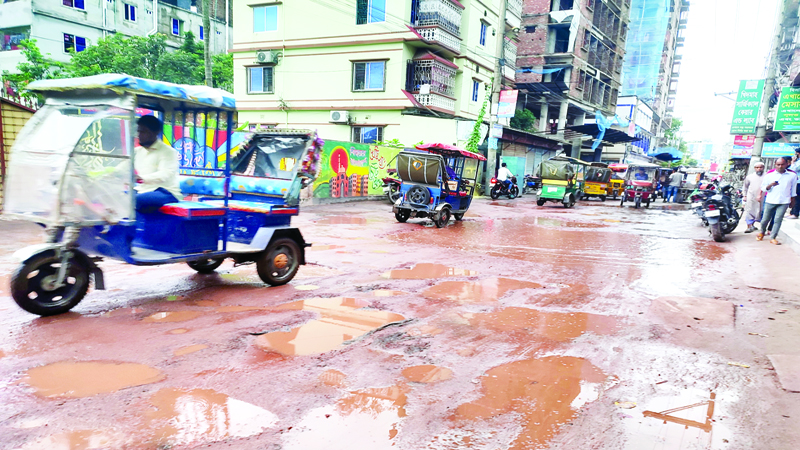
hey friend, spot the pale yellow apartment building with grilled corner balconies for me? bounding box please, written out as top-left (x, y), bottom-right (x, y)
top-left (232, 0), bottom-right (521, 145)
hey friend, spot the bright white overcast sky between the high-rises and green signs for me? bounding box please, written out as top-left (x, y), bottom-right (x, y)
top-left (674, 0), bottom-right (778, 143)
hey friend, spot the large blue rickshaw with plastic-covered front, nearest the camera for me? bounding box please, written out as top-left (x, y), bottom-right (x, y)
top-left (4, 74), bottom-right (322, 316)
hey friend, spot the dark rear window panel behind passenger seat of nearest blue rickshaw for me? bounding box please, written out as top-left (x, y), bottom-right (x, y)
top-left (231, 134), bottom-right (311, 180)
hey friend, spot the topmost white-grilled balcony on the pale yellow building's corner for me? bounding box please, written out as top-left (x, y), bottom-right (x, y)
top-left (411, 0), bottom-right (464, 53)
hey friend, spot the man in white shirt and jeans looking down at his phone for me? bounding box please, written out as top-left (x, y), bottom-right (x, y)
top-left (756, 156), bottom-right (797, 245)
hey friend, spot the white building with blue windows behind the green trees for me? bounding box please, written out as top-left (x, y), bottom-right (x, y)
top-left (0, 0), bottom-right (230, 72)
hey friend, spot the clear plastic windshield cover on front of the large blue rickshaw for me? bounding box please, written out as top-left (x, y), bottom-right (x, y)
top-left (4, 104), bottom-right (132, 224)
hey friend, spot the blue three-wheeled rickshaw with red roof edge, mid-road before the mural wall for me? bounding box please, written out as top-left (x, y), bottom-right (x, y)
top-left (392, 144), bottom-right (486, 228)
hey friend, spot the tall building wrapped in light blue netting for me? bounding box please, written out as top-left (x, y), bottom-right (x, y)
top-left (621, 0), bottom-right (690, 144)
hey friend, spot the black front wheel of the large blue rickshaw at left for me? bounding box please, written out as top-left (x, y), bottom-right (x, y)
top-left (11, 254), bottom-right (89, 316)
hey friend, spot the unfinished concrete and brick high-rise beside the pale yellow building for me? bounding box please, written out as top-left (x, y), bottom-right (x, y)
top-left (516, 0), bottom-right (630, 159)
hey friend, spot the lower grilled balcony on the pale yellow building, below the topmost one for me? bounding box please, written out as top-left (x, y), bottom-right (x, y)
top-left (406, 52), bottom-right (458, 113)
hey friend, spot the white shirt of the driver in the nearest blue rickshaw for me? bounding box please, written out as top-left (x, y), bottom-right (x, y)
top-left (133, 140), bottom-right (181, 198)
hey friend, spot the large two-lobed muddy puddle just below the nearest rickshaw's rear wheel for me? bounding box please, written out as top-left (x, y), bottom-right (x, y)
top-left (255, 297), bottom-right (405, 355)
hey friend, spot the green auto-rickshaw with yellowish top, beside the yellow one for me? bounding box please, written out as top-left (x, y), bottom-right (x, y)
top-left (536, 156), bottom-right (589, 208)
